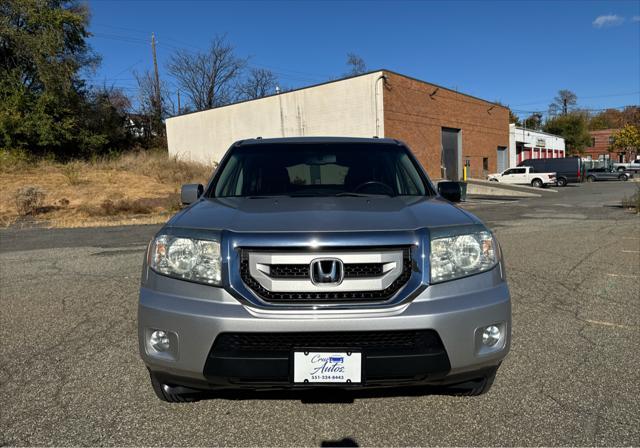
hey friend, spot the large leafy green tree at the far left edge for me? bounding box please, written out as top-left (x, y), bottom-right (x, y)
top-left (0, 0), bottom-right (122, 157)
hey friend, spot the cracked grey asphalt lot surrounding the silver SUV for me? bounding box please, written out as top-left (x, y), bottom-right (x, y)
top-left (0, 182), bottom-right (640, 446)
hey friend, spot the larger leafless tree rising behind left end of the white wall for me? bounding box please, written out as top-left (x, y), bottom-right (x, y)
top-left (167, 36), bottom-right (247, 110)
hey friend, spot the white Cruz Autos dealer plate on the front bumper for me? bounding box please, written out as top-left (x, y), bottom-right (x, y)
top-left (293, 352), bottom-right (362, 383)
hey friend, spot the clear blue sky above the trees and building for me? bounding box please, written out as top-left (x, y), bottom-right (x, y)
top-left (89, 1), bottom-right (640, 115)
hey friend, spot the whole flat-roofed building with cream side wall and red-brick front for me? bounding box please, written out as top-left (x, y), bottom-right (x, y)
top-left (167, 70), bottom-right (509, 179)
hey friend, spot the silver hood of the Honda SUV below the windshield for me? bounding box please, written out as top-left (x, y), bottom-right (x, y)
top-left (168, 197), bottom-right (479, 232)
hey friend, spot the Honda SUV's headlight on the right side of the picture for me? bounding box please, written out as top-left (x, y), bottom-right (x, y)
top-left (430, 231), bottom-right (498, 283)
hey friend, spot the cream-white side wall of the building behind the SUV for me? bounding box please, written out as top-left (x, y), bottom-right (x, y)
top-left (167, 72), bottom-right (384, 163)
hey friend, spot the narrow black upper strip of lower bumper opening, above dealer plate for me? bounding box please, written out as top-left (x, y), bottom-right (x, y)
top-left (210, 330), bottom-right (444, 356)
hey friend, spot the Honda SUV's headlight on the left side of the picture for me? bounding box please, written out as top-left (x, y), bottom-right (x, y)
top-left (148, 235), bottom-right (222, 285)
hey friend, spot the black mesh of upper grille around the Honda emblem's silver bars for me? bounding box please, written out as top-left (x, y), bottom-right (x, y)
top-left (240, 248), bottom-right (412, 304)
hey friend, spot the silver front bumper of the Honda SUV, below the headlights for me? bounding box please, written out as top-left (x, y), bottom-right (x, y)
top-left (138, 266), bottom-right (511, 388)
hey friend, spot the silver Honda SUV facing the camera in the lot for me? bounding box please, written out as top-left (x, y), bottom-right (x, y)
top-left (138, 138), bottom-right (511, 402)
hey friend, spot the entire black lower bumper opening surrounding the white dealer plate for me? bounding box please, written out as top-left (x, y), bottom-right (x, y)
top-left (203, 329), bottom-right (451, 387)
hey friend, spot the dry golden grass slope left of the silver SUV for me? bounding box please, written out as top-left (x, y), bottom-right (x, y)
top-left (0, 151), bottom-right (214, 227)
